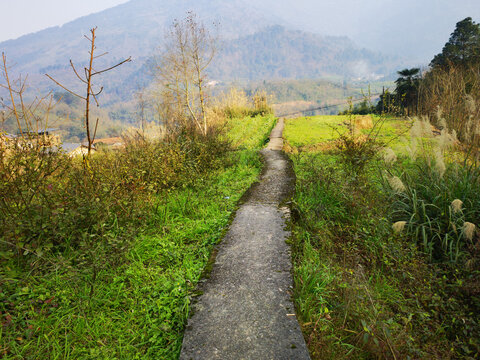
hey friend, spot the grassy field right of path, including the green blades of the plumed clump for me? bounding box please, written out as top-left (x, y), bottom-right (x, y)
top-left (284, 117), bottom-right (480, 359)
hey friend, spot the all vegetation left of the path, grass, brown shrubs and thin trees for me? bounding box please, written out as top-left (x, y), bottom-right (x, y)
top-left (0, 16), bottom-right (276, 360)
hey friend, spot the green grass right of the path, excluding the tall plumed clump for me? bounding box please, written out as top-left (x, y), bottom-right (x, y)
top-left (285, 117), bottom-right (480, 359)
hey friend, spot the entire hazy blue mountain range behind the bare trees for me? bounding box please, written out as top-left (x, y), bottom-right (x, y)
top-left (0, 0), bottom-right (404, 104)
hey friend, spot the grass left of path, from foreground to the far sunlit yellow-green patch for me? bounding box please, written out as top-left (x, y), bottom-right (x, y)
top-left (0, 117), bottom-right (275, 359)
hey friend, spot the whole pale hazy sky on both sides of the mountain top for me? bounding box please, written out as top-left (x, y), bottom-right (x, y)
top-left (0, 0), bottom-right (480, 62)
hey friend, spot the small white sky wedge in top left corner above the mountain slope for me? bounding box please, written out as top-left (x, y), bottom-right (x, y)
top-left (0, 0), bottom-right (128, 42)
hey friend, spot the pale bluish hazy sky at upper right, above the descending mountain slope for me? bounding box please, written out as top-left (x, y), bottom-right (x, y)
top-left (252, 0), bottom-right (480, 61)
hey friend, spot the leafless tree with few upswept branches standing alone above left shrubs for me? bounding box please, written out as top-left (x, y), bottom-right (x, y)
top-left (45, 27), bottom-right (131, 156)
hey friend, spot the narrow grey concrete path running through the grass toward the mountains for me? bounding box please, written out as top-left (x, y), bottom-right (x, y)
top-left (180, 120), bottom-right (310, 360)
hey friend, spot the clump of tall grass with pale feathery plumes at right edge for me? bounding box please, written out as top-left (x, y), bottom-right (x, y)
top-left (384, 117), bottom-right (480, 265)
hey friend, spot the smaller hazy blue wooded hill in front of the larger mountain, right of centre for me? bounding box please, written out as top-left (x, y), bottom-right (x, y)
top-left (211, 25), bottom-right (401, 80)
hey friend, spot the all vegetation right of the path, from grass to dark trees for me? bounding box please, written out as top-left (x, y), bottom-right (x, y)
top-left (284, 18), bottom-right (480, 359)
